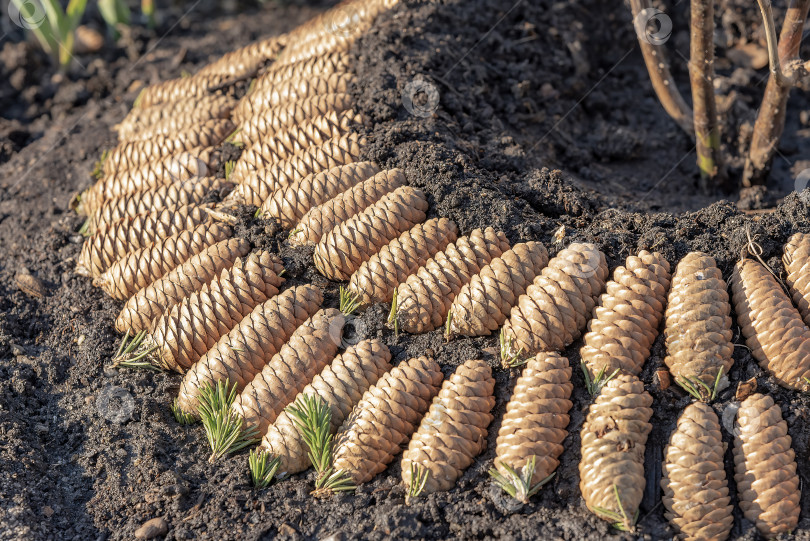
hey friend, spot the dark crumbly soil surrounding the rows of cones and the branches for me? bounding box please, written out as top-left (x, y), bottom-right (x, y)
top-left (0, 0), bottom-right (810, 539)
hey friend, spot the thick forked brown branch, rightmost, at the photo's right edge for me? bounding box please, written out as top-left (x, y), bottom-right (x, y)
top-left (742, 0), bottom-right (810, 186)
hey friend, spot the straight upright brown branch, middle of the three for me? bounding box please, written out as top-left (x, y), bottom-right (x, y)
top-left (689, 0), bottom-right (725, 193)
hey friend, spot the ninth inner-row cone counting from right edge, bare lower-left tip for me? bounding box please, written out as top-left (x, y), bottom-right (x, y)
top-left (312, 186), bottom-right (428, 280)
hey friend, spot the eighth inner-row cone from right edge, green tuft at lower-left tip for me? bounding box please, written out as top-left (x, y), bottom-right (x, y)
top-left (349, 218), bottom-right (458, 306)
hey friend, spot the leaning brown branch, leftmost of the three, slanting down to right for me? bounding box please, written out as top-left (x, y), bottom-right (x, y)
top-left (630, 0), bottom-right (695, 137)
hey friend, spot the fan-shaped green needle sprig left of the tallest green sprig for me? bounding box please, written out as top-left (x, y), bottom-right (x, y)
top-left (199, 380), bottom-right (260, 462)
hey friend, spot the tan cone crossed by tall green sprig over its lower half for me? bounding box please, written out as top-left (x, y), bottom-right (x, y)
top-left (261, 339), bottom-right (391, 474)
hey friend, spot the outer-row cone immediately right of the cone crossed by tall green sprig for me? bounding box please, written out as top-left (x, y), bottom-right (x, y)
top-left (333, 357), bottom-right (442, 484)
